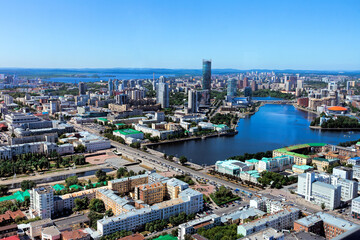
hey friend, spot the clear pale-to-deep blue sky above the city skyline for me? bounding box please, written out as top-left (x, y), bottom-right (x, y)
top-left (0, 0), bottom-right (360, 70)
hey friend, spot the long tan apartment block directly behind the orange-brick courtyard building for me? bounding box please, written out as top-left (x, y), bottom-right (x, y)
top-left (108, 174), bottom-right (149, 194)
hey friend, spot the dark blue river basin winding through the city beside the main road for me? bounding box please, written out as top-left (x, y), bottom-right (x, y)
top-left (150, 104), bottom-right (360, 165)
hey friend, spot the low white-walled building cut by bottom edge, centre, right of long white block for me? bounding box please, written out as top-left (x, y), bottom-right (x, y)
top-left (178, 214), bottom-right (221, 240)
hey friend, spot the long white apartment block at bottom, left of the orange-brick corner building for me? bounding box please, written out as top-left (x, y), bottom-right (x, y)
top-left (237, 208), bottom-right (300, 236)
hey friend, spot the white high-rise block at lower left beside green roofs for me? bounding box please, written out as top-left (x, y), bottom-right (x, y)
top-left (29, 186), bottom-right (54, 219)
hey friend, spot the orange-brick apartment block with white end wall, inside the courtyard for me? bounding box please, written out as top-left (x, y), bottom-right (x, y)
top-left (134, 182), bottom-right (166, 205)
